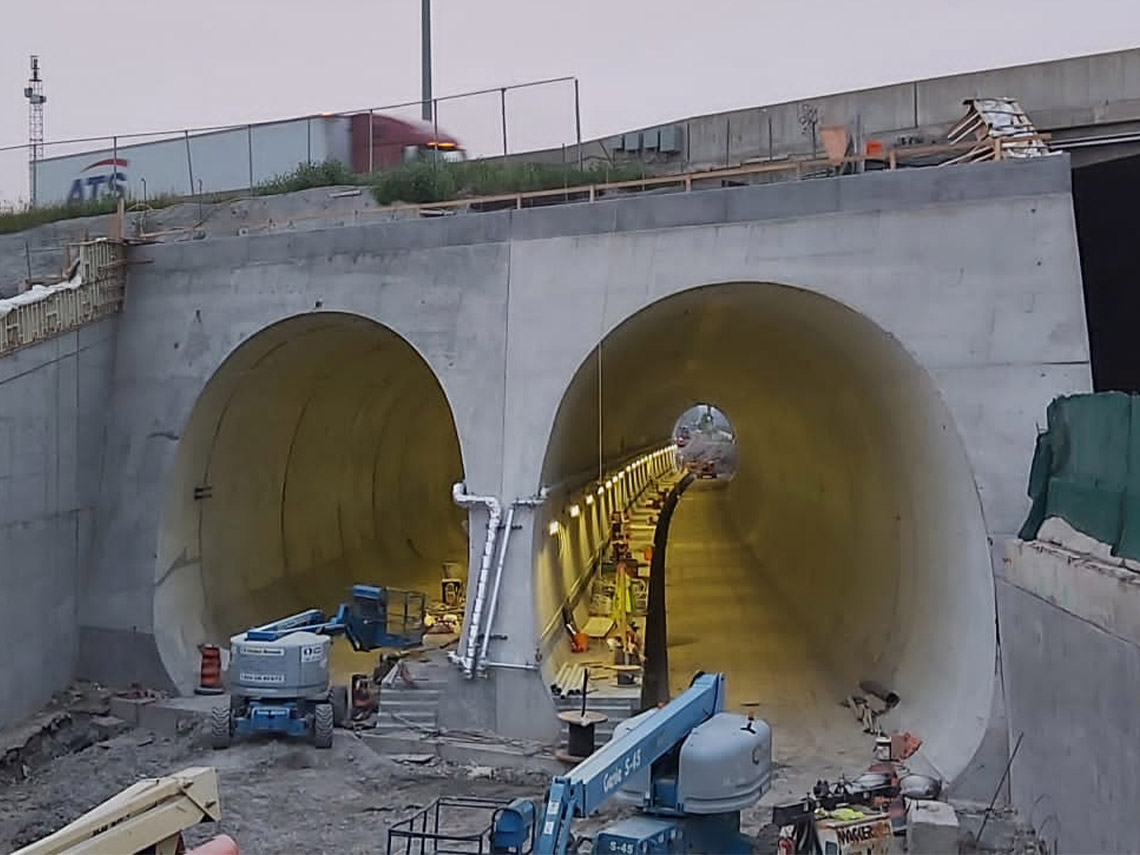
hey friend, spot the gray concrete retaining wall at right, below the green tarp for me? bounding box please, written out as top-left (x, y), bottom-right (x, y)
top-left (998, 542), bottom-right (1140, 853)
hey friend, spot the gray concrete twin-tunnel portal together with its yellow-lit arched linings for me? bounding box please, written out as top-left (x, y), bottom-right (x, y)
top-left (0, 158), bottom-right (1089, 776)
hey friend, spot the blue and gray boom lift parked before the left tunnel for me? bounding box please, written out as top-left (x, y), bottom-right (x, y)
top-left (210, 585), bottom-right (426, 749)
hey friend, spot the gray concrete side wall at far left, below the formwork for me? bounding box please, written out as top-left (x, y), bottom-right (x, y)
top-left (0, 319), bottom-right (117, 726)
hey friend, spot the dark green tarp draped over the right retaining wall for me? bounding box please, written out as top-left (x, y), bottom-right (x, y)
top-left (1019, 392), bottom-right (1140, 559)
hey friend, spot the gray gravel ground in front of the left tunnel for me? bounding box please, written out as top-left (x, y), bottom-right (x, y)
top-left (0, 731), bottom-right (546, 853)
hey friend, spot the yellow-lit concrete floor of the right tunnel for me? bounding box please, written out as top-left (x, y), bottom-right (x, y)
top-left (665, 480), bottom-right (873, 785)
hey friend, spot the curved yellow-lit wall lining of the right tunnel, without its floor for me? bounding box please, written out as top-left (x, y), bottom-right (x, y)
top-left (536, 283), bottom-right (995, 777)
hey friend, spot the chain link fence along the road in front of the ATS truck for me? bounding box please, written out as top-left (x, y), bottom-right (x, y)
top-left (0, 78), bottom-right (581, 211)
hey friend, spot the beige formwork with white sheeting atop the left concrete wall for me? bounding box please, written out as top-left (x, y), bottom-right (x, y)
top-left (0, 238), bottom-right (127, 357)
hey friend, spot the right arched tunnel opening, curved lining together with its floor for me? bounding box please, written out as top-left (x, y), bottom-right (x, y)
top-left (535, 283), bottom-right (996, 780)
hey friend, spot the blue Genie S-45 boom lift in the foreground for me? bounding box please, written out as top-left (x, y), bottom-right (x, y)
top-left (388, 674), bottom-right (772, 855)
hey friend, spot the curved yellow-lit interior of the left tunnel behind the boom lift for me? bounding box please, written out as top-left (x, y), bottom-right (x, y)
top-left (154, 312), bottom-right (467, 691)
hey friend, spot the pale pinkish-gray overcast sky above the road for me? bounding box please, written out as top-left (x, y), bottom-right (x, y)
top-left (0, 0), bottom-right (1140, 201)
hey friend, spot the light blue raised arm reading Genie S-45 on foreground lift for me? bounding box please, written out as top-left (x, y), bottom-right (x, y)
top-left (535, 674), bottom-right (725, 855)
